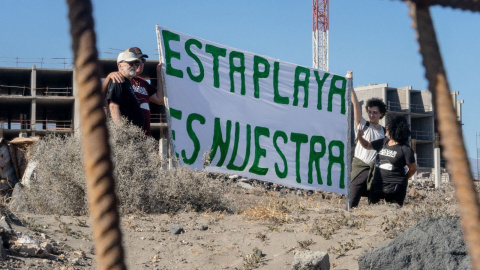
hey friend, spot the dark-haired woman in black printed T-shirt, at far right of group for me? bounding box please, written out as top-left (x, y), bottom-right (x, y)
top-left (357, 115), bottom-right (417, 206)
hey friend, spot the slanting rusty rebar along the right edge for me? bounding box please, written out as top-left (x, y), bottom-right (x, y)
top-left (409, 2), bottom-right (480, 269)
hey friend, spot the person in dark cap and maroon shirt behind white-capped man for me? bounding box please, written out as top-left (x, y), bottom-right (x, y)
top-left (102, 47), bottom-right (164, 135)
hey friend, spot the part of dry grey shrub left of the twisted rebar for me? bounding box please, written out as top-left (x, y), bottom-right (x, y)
top-left (25, 135), bottom-right (87, 215)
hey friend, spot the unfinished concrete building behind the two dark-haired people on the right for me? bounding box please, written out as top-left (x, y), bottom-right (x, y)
top-left (355, 83), bottom-right (463, 181)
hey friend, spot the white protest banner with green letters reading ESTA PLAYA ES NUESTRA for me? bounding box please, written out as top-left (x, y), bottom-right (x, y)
top-left (157, 25), bottom-right (349, 194)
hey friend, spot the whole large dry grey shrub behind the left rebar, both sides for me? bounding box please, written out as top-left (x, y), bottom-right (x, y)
top-left (25, 118), bottom-right (230, 215)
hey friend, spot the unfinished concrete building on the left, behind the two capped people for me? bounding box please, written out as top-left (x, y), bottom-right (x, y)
top-left (0, 59), bottom-right (167, 140)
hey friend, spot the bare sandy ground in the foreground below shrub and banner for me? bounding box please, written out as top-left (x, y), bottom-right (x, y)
top-left (4, 181), bottom-right (446, 270)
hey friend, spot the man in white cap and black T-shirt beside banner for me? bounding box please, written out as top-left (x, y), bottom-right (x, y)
top-left (106, 52), bottom-right (145, 128)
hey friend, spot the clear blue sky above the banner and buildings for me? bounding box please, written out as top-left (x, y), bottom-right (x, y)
top-left (0, 0), bottom-right (480, 158)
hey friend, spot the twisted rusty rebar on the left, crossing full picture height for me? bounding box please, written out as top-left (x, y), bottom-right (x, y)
top-left (67, 0), bottom-right (126, 269)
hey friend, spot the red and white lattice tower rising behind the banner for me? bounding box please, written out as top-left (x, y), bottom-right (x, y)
top-left (312, 0), bottom-right (329, 71)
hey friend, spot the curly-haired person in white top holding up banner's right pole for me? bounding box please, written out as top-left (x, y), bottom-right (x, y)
top-left (347, 71), bottom-right (387, 207)
